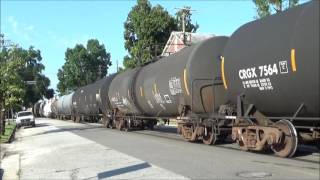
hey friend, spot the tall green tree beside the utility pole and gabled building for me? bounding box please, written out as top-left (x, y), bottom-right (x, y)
top-left (123, 0), bottom-right (198, 69)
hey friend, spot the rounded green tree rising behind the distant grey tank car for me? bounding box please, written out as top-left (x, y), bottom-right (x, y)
top-left (57, 39), bottom-right (111, 95)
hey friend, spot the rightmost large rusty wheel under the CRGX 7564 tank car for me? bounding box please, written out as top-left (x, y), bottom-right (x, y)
top-left (271, 119), bottom-right (298, 157)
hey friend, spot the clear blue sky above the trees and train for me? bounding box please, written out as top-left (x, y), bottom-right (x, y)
top-left (1, 0), bottom-right (308, 89)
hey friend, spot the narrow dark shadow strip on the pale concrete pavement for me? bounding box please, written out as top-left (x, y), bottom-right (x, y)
top-left (98, 162), bottom-right (151, 179)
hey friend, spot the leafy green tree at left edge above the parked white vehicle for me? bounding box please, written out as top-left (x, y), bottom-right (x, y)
top-left (0, 46), bottom-right (53, 108)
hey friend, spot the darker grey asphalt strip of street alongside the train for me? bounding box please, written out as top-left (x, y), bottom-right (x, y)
top-left (47, 118), bottom-right (320, 179)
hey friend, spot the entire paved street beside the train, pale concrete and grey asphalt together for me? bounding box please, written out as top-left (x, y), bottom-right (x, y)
top-left (1, 119), bottom-right (320, 179)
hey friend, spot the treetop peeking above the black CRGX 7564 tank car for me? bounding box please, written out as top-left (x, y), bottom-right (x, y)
top-left (253, 0), bottom-right (299, 19)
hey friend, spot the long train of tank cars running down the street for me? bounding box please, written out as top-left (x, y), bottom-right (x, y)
top-left (34, 1), bottom-right (320, 157)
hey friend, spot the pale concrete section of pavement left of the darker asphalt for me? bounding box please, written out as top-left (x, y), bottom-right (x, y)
top-left (2, 119), bottom-right (186, 180)
